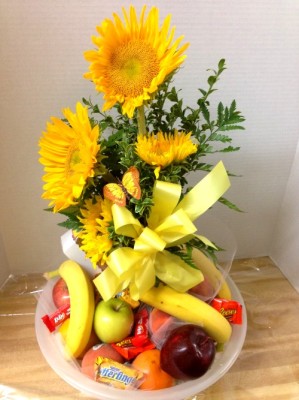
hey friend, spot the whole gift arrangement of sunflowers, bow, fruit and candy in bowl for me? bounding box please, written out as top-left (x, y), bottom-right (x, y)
top-left (36, 6), bottom-right (247, 400)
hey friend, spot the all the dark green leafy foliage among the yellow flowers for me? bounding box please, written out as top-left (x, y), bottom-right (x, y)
top-left (59, 59), bottom-right (245, 247)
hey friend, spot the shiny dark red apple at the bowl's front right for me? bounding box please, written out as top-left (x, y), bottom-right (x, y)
top-left (161, 324), bottom-right (216, 380)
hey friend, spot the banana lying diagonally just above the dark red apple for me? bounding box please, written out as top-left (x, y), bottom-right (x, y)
top-left (140, 285), bottom-right (232, 344)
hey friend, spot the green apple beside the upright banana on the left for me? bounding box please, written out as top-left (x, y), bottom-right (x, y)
top-left (93, 298), bottom-right (134, 343)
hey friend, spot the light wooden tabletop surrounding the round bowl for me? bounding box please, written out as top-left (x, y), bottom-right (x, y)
top-left (0, 257), bottom-right (299, 400)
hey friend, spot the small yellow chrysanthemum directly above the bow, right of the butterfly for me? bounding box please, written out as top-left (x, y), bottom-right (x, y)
top-left (136, 131), bottom-right (197, 177)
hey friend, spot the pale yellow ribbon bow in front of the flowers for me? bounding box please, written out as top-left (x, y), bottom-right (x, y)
top-left (94, 161), bottom-right (230, 300)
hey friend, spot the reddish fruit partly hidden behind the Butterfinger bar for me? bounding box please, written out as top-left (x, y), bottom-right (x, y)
top-left (81, 343), bottom-right (125, 379)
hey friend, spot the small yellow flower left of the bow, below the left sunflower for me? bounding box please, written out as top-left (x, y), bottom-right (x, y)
top-left (74, 196), bottom-right (113, 267)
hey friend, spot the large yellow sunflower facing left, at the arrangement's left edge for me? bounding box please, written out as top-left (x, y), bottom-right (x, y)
top-left (39, 103), bottom-right (100, 212)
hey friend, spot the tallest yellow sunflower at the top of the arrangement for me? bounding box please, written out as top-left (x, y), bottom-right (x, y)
top-left (84, 6), bottom-right (188, 118)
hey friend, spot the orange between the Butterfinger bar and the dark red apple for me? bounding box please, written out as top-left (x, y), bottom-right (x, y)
top-left (132, 349), bottom-right (175, 390)
